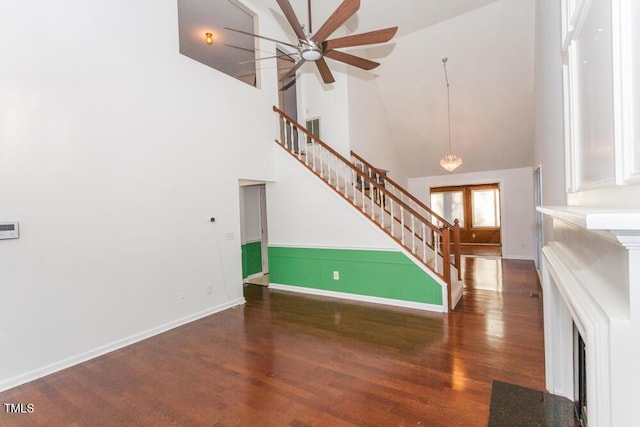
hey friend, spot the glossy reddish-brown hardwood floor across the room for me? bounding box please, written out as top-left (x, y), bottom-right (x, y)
top-left (0, 258), bottom-right (544, 426)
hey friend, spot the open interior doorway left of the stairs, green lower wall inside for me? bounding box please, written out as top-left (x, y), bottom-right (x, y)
top-left (240, 182), bottom-right (269, 286)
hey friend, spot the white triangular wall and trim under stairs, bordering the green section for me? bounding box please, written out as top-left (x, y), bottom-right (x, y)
top-left (267, 147), bottom-right (450, 312)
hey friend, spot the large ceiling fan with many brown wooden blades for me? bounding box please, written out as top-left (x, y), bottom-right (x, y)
top-left (226, 0), bottom-right (398, 83)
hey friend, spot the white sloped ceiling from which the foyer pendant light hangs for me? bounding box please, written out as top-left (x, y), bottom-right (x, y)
top-left (376, 0), bottom-right (535, 177)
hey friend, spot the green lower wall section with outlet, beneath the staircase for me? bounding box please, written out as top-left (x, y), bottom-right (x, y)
top-left (269, 246), bottom-right (442, 305)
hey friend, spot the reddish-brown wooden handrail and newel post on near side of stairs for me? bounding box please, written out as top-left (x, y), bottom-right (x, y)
top-left (273, 106), bottom-right (451, 282)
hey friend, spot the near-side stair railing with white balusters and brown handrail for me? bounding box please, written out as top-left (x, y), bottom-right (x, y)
top-left (273, 107), bottom-right (451, 309)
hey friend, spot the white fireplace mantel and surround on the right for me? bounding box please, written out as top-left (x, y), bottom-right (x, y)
top-left (538, 206), bottom-right (640, 426)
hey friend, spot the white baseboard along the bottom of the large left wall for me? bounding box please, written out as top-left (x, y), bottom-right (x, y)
top-left (0, 298), bottom-right (245, 392)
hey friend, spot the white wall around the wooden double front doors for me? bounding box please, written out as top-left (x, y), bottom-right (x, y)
top-left (409, 168), bottom-right (535, 259)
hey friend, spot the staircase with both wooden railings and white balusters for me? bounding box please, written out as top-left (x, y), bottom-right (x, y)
top-left (273, 107), bottom-right (462, 311)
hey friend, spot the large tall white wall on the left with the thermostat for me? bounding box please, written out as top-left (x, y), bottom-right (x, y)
top-left (0, 0), bottom-right (278, 390)
